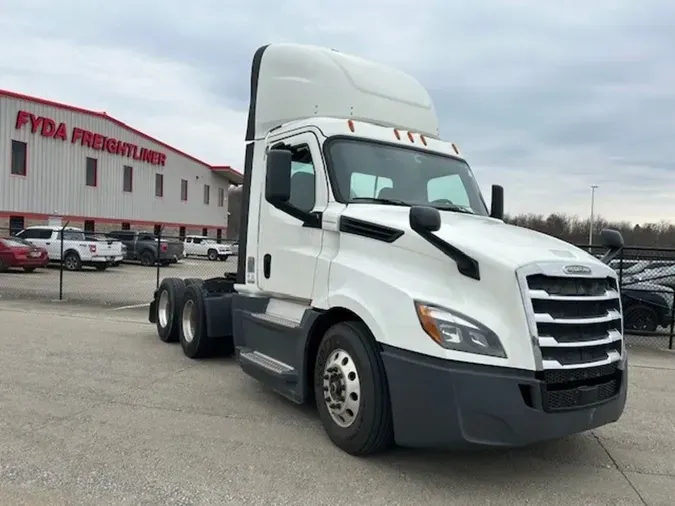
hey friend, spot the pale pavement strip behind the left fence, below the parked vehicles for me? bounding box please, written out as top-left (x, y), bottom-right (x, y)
top-left (0, 257), bottom-right (237, 307)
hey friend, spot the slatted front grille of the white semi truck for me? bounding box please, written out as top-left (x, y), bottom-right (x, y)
top-left (519, 264), bottom-right (624, 411)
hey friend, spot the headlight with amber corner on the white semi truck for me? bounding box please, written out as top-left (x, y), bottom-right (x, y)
top-left (415, 302), bottom-right (506, 358)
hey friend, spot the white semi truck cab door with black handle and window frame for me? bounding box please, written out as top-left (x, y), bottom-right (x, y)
top-left (256, 132), bottom-right (328, 302)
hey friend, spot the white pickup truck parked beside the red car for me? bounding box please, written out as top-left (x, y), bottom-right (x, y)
top-left (17, 225), bottom-right (123, 271)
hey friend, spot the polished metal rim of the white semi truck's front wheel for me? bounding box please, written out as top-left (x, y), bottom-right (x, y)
top-left (323, 349), bottom-right (361, 428)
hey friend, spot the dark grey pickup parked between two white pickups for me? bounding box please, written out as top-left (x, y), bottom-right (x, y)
top-left (107, 230), bottom-right (184, 266)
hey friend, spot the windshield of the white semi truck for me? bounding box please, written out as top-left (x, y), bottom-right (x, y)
top-left (327, 139), bottom-right (488, 216)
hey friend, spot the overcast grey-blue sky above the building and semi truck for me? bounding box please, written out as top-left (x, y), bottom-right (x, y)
top-left (0, 0), bottom-right (675, 221)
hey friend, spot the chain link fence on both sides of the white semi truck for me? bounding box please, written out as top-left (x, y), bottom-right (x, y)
top-left (0, 223), bottom-right (675, 349)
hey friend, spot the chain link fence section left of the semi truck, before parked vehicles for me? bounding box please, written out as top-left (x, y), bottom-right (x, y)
top-left (0, 223), bottom-right (238, 308)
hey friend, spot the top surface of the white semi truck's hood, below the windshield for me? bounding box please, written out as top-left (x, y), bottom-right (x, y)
top-left (343, 204), bottom-right (613, 272)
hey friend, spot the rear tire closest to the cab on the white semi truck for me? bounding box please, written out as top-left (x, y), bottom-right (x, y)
top-left (180, 283), bottom-right (215, 359)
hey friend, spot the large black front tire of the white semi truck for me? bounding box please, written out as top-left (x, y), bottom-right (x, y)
top-left (314, 322), bottom-right (394, 455)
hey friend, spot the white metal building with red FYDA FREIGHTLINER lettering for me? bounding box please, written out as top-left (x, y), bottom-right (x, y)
top-left (0, 90), bottom-right (242, 238)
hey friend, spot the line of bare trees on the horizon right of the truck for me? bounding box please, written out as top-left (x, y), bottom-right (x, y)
top-left (504, 213), bottom-right (675, 248)
